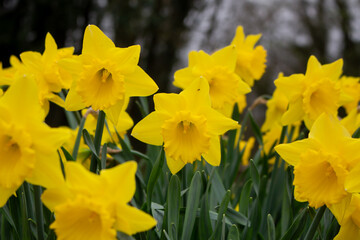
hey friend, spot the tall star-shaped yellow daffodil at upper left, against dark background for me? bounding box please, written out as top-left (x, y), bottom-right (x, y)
top-left (62, 25), bottom-right (158, 124)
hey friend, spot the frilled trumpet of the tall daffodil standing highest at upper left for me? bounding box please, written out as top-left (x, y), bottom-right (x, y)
top-left (76, 61), bottom-right (125, 110)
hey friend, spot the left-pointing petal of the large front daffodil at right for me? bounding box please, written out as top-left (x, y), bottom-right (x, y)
top-left (275, 139), bottom-right (318, 166)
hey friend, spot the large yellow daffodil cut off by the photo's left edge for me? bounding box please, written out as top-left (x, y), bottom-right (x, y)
top-left (0, 77), bottom-right (68, 206)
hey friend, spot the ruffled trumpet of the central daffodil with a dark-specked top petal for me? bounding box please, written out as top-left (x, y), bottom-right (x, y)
top-left (162, 111), bottom-right (210, 163)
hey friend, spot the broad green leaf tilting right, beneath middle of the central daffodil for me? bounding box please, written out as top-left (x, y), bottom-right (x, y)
top-left (181, 172), bottom-right (202, 240)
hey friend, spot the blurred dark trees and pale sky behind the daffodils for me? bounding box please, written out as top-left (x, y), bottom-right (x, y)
top-left (0, 0), bottom-right (360, 126)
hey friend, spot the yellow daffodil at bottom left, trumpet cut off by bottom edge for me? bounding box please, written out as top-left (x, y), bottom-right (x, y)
top-left (42, 161), bottom-right (156, 237)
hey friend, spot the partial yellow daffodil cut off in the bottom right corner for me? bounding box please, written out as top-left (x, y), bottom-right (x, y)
top-left (329, 193), bottom-right (360, 240)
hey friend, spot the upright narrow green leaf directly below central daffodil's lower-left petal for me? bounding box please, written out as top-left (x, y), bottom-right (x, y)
top-left (167, 175), bottom-right (181, 240)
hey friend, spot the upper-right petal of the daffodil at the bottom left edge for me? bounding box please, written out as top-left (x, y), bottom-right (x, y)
top-left (100, 161), bottom-right (137, 204)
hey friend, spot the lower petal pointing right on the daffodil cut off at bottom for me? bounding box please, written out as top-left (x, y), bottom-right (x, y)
top-left (114, 205), bottom-right (156, 235)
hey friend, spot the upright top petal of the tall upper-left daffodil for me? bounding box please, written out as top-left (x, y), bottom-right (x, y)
top-left (82, 25), bottom-right (115, 56)
